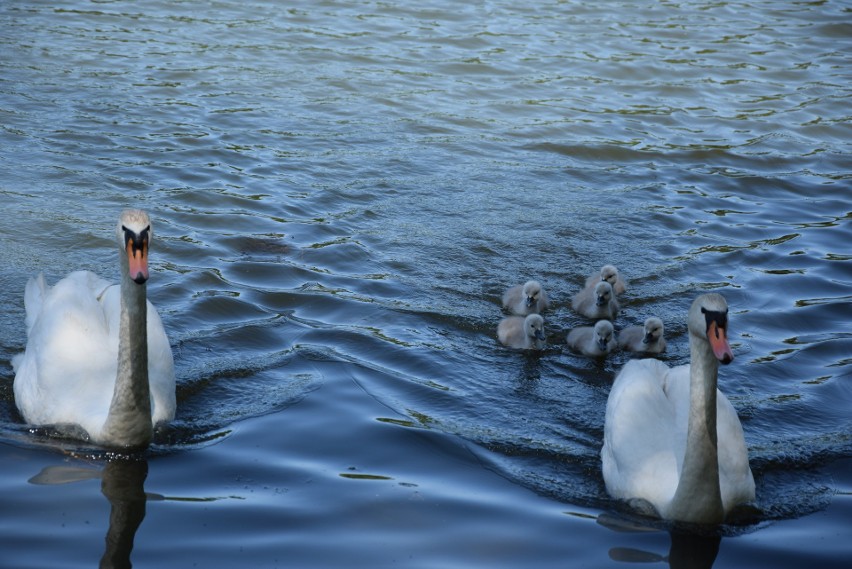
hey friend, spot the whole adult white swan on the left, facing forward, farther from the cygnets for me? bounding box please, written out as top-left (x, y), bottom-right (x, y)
top-left (12, 210), bottom-right (175, 448)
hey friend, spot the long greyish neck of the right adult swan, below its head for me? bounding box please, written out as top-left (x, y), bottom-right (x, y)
top-left (667, 334), bottom-right (725, 524)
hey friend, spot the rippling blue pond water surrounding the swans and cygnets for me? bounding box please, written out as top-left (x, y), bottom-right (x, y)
top-left (0, 0), bottom-right (852, 568)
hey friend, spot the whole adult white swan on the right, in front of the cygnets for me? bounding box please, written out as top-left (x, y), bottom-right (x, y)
top-left (601, 294), bottom-right (754, 524)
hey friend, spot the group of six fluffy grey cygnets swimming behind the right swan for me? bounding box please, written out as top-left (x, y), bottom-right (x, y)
top-left (497, 265), bottom-right (666, 357)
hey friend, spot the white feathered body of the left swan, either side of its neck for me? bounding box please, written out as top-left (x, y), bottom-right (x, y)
top-left (13, 271), bottom-right (175, 438)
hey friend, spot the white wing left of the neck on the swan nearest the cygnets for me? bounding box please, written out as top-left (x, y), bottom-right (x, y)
top-left (601, 359), bottom-right (678, 511)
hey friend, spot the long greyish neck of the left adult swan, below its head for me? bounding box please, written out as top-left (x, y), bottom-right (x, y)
top-left (102, 254), bottom-right (152, 447)
